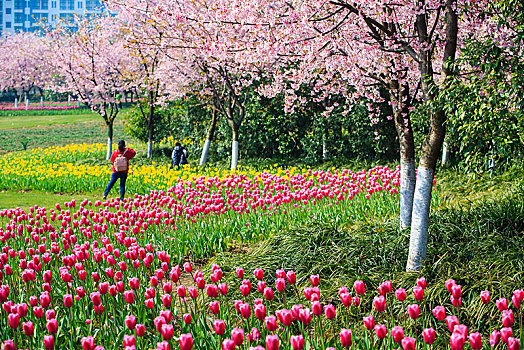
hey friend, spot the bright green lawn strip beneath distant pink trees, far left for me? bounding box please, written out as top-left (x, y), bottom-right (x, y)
top-left (0, 113), bottom-right (103, 130)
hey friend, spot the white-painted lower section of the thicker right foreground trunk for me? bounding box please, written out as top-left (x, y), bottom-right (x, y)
top-left (406, 166), bottom-right (435, 271)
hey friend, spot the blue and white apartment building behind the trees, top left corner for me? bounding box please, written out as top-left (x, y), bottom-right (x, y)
top-left (0, 0), bottom-right (105, 33)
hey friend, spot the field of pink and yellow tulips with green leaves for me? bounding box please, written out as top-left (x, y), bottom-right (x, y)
top-left (0, 144), bottom-right (524, 350)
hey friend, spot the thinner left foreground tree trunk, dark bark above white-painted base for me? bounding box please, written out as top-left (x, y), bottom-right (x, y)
top-left (389, 81), bottom-right (415, 230)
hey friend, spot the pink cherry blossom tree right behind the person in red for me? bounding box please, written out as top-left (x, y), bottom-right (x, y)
top-left (47, 17), bottom-right (136, 159)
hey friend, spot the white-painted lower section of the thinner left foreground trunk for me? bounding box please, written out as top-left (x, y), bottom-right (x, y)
top-left (400, 159), bottom-right (415, 230)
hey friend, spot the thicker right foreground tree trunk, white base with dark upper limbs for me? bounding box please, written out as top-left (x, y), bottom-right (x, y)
top-left (406, 0), bottom-right (458, 271)
